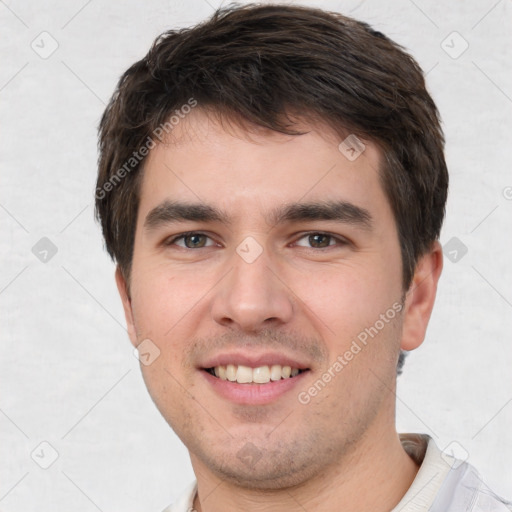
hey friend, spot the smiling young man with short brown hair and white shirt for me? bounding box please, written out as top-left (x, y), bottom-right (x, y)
top-left (96, 5), bottom-right (510, 512)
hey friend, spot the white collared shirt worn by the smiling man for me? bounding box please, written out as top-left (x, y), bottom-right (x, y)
top-left (162, 434), bottom-right (512, 512)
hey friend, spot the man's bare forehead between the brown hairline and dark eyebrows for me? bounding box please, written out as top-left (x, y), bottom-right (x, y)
top-left (139, 108), bottom-right (386, 225)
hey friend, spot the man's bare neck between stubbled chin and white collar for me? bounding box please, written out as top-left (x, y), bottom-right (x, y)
top-left (191, 422), bottom-right (419, 512)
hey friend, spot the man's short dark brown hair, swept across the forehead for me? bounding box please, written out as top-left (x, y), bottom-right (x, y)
top-left (96, 5), bottom-right (448, 289)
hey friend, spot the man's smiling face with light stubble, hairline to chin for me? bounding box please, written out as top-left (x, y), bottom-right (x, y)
top-left (117, 110), bottom-right (440, 488)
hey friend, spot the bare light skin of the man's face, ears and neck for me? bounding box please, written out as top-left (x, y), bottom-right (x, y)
top-left (116, 108), bottom-right (442, 512)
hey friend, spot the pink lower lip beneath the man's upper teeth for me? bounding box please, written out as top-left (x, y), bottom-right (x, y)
top-left (200, 363), bottom-right (309, 405)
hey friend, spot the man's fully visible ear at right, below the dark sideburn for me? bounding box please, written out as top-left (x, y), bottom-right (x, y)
top-left (400, 242), bottom-right (443, 350)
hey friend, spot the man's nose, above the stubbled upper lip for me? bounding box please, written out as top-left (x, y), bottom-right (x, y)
top-left (212, 243), bottom-right (293, 332)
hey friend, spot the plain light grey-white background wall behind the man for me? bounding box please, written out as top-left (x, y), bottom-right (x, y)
top-left (0, 0), bottom-right (512, 512)
